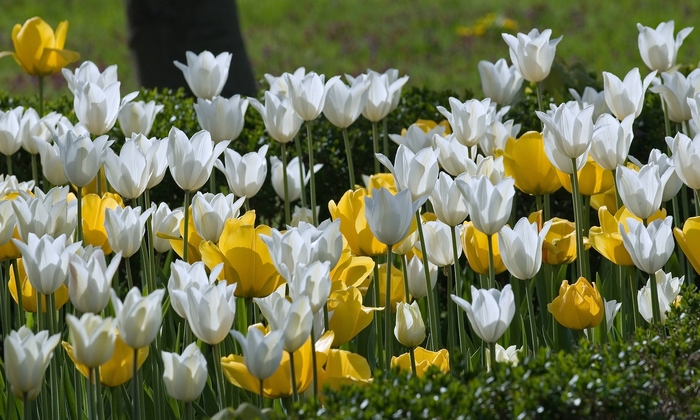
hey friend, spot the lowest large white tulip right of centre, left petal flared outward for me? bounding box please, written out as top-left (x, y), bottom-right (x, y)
top-left (450, 284), bottom-right (515, 343)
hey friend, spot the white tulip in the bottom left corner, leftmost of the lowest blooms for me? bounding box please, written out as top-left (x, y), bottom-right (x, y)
top-left (4, 325), bottom-right (61, 401)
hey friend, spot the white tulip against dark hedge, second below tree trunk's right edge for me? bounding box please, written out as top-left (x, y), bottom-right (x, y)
top-left (214, 144), bottom-right (266, 200)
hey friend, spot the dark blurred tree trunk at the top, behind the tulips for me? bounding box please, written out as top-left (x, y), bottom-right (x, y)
top-left (126, 0), bottom-right (257, 98)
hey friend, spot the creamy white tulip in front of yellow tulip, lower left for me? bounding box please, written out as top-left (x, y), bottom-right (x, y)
top-left (66, 313), bottom-right (117, 369)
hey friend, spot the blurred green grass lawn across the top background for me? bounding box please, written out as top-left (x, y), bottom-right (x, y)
top-left (0, 0), bottom-right (700, 100)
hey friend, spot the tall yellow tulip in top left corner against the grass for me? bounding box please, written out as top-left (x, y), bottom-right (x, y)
top-left (0, 17), bottom-right (80, 76)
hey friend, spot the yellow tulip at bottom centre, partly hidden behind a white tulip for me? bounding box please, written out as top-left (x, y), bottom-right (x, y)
top-left (221, 332), bottom-right (333, 398)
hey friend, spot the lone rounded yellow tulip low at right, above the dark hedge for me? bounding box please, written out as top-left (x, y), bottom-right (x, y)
top-left (547, 277), bottom-right (605, 330)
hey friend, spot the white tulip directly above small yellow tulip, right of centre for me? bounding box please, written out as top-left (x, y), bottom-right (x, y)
top-left (455, 176), bottom-right (515, 235)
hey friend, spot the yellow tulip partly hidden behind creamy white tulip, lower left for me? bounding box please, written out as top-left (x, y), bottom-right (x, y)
top-left (62, 329), bottom-right (150, 387)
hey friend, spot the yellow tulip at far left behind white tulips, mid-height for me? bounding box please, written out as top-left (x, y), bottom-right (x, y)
top-left (83, 193), bottom-right (124, 255)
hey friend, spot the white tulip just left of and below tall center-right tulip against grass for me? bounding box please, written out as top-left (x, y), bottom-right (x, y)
top-left (479, 58), bottom-right (523, 106)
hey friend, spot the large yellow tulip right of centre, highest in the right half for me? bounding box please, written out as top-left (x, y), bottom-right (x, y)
top-left (502, 131), bottom-right (561, 195)
